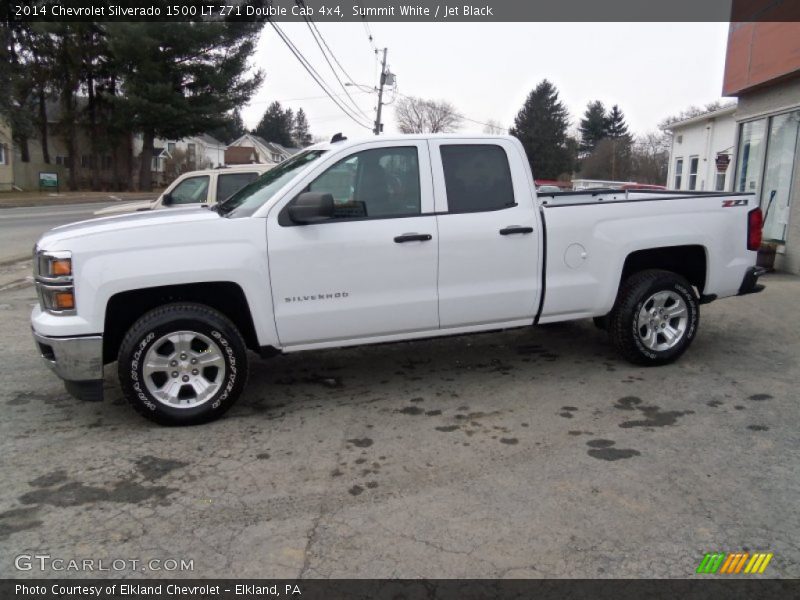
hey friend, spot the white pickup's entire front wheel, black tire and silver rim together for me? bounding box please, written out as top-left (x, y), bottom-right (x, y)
top-left (118, 303), bottom-right (247, 425)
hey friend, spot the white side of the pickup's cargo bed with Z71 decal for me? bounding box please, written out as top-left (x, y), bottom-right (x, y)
top-left (538, 190), bottom-right (758, 323)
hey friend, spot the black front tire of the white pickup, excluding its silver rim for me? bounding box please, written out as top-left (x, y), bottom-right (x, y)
top-left (117, 303), bottom-right (248, 425)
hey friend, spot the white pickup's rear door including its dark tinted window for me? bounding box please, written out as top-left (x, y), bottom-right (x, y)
top-left (429, 139), bottom-right (541, 328)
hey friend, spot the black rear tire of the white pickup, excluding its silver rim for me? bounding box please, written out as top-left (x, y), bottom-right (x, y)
top-left (608, 269), bottom-right (700, 366)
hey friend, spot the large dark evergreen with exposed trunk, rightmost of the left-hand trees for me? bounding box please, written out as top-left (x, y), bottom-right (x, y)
top-left (105, 22), bottom-right (261, 190)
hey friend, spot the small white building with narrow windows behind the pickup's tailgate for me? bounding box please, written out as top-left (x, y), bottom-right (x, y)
top-left (666, 105), bottom-right (736, 192)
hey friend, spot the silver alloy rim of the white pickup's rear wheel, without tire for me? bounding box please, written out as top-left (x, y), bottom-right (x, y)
top-left (636, 291), bottom-right (689, 352)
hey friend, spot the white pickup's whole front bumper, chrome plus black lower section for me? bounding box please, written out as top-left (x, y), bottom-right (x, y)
top-left (33, 330), bottom-right (103, 400)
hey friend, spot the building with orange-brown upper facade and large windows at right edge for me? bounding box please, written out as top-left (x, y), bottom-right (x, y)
top-left (722, 17), bottom-right (800, 274)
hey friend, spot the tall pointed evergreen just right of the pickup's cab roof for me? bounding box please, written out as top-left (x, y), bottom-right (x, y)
top-left (509, 79), bottom-right (572, 179)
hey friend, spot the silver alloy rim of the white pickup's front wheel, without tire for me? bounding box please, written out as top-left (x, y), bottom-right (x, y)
top-left (142, 331), bottom-right (225, 408)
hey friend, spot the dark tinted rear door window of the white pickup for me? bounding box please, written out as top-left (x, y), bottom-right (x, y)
top-left (440, 144), bottom-right (516, 213)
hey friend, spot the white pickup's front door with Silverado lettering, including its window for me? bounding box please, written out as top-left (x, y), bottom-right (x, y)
top-left (267, 141), bottom-right (439, 347)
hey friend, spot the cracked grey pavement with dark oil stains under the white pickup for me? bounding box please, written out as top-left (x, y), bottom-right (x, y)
top-left (0, 267), bottom-right (800, 578)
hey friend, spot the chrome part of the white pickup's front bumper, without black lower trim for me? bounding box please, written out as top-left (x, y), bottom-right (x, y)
top-left (33, 331), bottom-right (103, 381)
